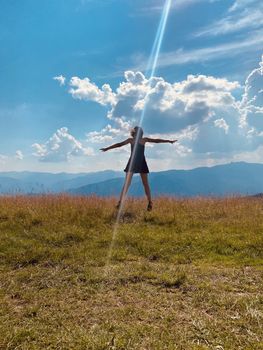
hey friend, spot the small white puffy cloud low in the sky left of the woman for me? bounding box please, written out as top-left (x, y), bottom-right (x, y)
top-left (32, 127), bottom-right (93, 162)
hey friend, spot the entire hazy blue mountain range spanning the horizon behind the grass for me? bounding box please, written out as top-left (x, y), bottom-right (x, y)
top-left (0, 162), bottom-right (263, 197)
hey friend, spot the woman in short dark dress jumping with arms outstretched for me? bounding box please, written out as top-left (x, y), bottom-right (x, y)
top-left (101, 126), bottom-right (177, 211)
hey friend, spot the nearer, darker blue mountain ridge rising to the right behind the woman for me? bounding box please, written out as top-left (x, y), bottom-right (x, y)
top-left (69, 162), bottom-right (263, 197)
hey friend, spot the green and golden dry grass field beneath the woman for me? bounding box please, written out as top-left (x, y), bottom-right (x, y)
top-left (0, 195), bottom-right (263, 350)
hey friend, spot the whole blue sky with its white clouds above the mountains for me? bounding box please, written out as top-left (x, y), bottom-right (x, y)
top-left (0, 0), bottom-right (263, 172)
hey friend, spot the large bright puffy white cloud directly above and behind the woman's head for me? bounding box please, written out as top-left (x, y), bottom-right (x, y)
top-left (66, 71), bottom-right (240, 142)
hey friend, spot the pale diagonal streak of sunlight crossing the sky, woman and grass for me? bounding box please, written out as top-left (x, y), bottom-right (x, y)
top-left (105, 0), bottom-right (172, 275)
